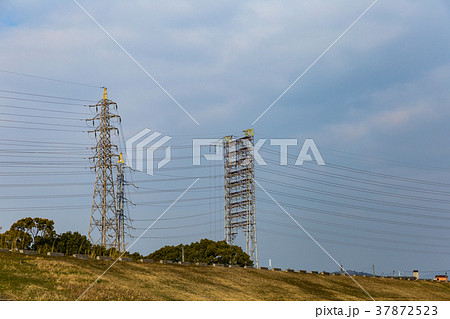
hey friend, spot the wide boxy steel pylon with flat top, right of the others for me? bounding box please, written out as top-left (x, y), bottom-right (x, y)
top-left (223, 129), bottom-right (258, 267)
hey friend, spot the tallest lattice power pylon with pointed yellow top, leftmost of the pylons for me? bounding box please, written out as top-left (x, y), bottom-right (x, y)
top-left (87, 88), bottom-right (123, 250)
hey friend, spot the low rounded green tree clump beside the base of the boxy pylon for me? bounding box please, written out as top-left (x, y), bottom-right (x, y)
top-left (147, 239), bottom-right (253, 266)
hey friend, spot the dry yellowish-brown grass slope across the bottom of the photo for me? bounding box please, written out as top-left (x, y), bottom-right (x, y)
top-left (0, 252), bottom-right (450, 300)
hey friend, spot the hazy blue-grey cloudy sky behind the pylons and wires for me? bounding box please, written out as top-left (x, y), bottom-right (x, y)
top-left (0, 0), bottom-right (450, 275)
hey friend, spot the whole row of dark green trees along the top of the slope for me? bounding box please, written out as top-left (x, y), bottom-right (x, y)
top-left (0, 217), bottom-right (253, 266)
